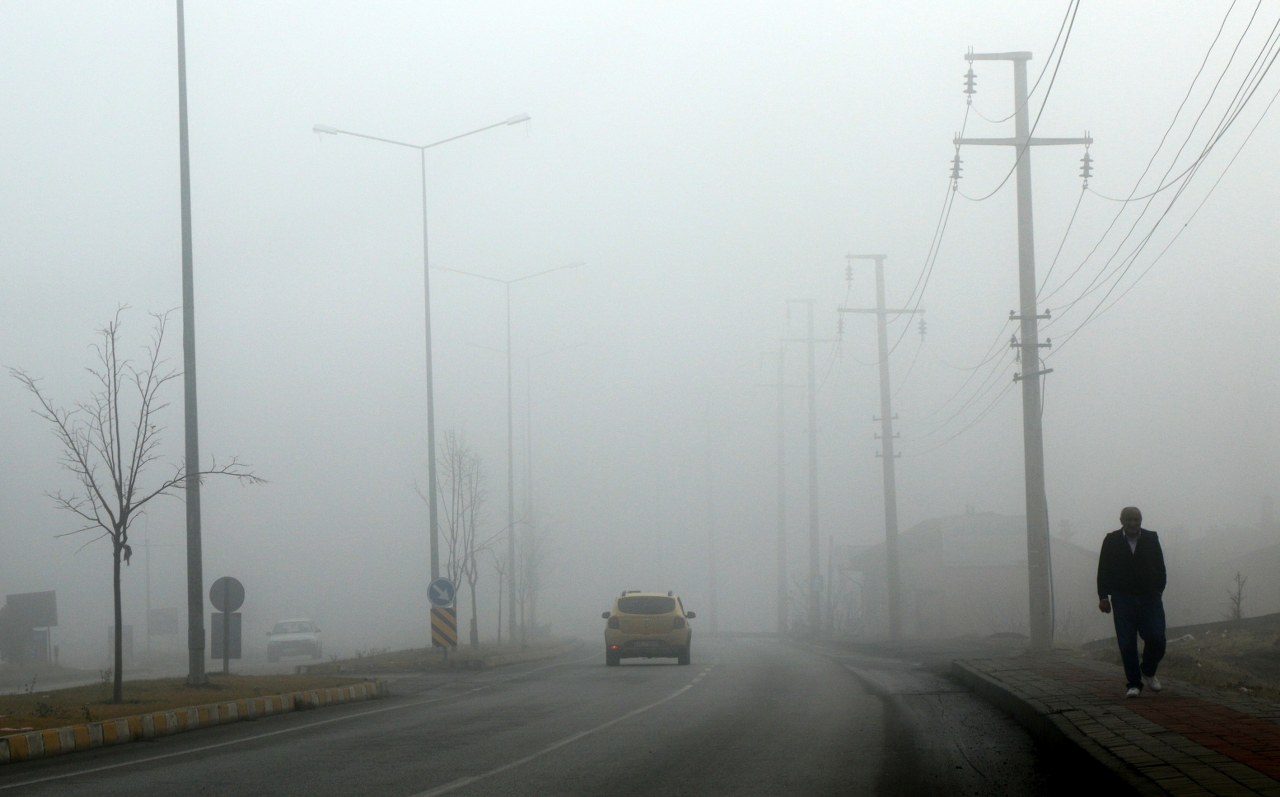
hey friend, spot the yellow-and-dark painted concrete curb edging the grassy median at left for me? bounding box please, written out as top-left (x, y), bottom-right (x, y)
top-left (0, 681), bottom-right (387, 765)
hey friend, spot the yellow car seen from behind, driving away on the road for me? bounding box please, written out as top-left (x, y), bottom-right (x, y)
top-left (600, 590), bottom-right (698, 667)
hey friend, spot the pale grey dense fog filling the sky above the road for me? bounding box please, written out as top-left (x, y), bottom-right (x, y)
top-left (0, 0), bottom-right (1280, 667)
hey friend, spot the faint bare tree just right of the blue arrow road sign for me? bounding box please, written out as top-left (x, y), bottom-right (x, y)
top-left (440, 430), bottom-right (492, 647)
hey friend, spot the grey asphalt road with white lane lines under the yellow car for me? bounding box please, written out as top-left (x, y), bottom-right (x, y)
top-left (0, 638), bottom-right (1066, 797)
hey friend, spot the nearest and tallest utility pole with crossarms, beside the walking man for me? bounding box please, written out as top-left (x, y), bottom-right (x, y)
top-left (955, 52), bottom-right (1093, 649)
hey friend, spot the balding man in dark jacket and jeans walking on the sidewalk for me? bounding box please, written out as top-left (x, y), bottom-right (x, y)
top-left (1098, 507), bottom-right (1166, 697)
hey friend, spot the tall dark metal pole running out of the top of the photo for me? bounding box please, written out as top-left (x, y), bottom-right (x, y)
top-left (178, 0), bottom-right (209, 686)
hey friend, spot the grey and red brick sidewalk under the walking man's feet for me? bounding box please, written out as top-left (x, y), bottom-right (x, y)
top-left (952, 654), bottom-right (1280, 797)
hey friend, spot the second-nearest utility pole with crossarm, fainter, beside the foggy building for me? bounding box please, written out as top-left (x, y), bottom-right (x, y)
top-left (840, 255), bottom-right (924, 641)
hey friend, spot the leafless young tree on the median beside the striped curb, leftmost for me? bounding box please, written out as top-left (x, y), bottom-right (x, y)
top-left (9, 306), bottom-right (264, 702)
